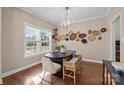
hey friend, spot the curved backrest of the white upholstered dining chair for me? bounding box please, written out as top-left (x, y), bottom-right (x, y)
top-left (41, 57), bottom-right (56, 73)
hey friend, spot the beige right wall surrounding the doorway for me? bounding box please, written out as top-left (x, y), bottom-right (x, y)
top-left (107, 7), bottom-right (124, 62)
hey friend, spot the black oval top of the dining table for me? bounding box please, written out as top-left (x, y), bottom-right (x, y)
top-left (45, 50), bottom-right (76, 58)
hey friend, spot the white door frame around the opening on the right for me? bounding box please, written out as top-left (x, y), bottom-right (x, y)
top-left (110, 12), bottom-right (121, 61)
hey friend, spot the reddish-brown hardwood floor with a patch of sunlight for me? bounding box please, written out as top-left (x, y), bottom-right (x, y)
top-left (3, 62), bottom-right (102, 85)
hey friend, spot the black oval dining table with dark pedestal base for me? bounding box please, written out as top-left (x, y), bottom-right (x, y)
top-left (45, 50), bottom-right (76, 78)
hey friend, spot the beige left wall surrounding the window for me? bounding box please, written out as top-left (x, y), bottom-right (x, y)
top-left (2, 8), bottom-right (54, 73)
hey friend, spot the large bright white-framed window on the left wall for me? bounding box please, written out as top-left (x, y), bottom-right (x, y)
top-left (25, 25), bottom-right (51, 57)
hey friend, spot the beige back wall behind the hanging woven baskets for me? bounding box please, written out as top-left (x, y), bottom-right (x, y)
top-left (58, 18), bottom-right (108, 61)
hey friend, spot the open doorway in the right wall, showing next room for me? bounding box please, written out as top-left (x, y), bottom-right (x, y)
top-left (110, 14), bottom-right (120, 62)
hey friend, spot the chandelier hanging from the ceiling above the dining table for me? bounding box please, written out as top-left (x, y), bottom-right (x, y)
top-left (61, 7), bottom-right (72, 31)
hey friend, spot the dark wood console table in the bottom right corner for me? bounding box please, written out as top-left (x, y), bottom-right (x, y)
top-left (103, 60), bottom-right (124, 85)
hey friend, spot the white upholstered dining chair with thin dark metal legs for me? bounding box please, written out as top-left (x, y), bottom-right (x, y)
top-left (41, 57), bottom-right (61, 84)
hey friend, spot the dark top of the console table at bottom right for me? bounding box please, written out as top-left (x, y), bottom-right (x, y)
top-left (103, 60), bottom-right (124, 85)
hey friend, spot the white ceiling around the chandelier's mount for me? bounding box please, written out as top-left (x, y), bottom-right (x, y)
top-left (21, 7), bottom-right (110, 25)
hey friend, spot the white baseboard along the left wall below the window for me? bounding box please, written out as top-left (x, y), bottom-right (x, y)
top-left (1, 61), bottom-right (41, 78)
